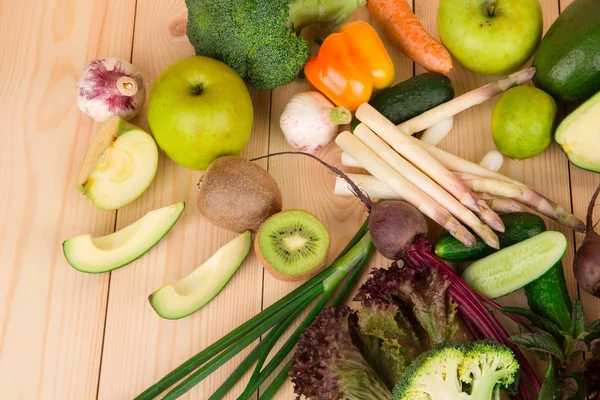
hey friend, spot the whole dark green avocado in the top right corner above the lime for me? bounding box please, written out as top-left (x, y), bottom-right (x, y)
top-left (533, 0), bottom-right (600, 103)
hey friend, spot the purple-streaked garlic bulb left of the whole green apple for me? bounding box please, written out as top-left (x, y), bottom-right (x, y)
top-left (77, 57), bottom-right (146, 122)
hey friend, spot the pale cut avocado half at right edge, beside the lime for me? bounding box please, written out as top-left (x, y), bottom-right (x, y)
top-left (554, 92), bottom-right (600, 172)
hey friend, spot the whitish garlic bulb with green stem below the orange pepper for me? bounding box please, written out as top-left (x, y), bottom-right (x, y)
top-left (279, 91), bottom-right (352, 154)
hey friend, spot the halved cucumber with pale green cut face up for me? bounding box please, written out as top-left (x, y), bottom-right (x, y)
top-left (462, 231), bottom-right (567, 299)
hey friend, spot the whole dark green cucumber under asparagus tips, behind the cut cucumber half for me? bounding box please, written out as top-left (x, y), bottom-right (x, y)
top-left (435, 212), bottom-right (546, 261)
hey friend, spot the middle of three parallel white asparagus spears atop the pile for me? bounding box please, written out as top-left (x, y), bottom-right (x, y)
top-left (354, 124), bottom-right (500, 249)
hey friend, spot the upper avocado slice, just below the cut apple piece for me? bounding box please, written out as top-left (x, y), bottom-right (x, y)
top-left (63, 202), bottom-right (185, 274)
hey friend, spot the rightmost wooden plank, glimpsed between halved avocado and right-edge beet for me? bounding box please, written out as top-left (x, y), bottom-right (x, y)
top-left (560, 0), bottom-right (600, 322)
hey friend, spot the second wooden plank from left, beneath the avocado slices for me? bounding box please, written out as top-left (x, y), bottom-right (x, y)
top-left (99, 0), bottom-right (270, 400)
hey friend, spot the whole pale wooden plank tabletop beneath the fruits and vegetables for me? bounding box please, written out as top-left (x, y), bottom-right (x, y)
top-left (0, 0), bottom-right (600, 400)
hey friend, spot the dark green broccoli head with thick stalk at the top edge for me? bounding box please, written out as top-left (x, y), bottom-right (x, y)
top-left (186, 0), bottom-right (364, 89)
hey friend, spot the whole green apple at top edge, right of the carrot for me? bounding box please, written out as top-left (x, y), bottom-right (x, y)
top-left (437, 0), bottom-right (543, 75)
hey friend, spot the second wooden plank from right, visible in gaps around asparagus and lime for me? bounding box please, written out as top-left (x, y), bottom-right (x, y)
top-left (415, 0), bottom-right (577, 382)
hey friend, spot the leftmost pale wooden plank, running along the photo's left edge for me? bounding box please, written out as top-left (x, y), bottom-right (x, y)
top-left (0, 0), bottom-right (135, 400)
